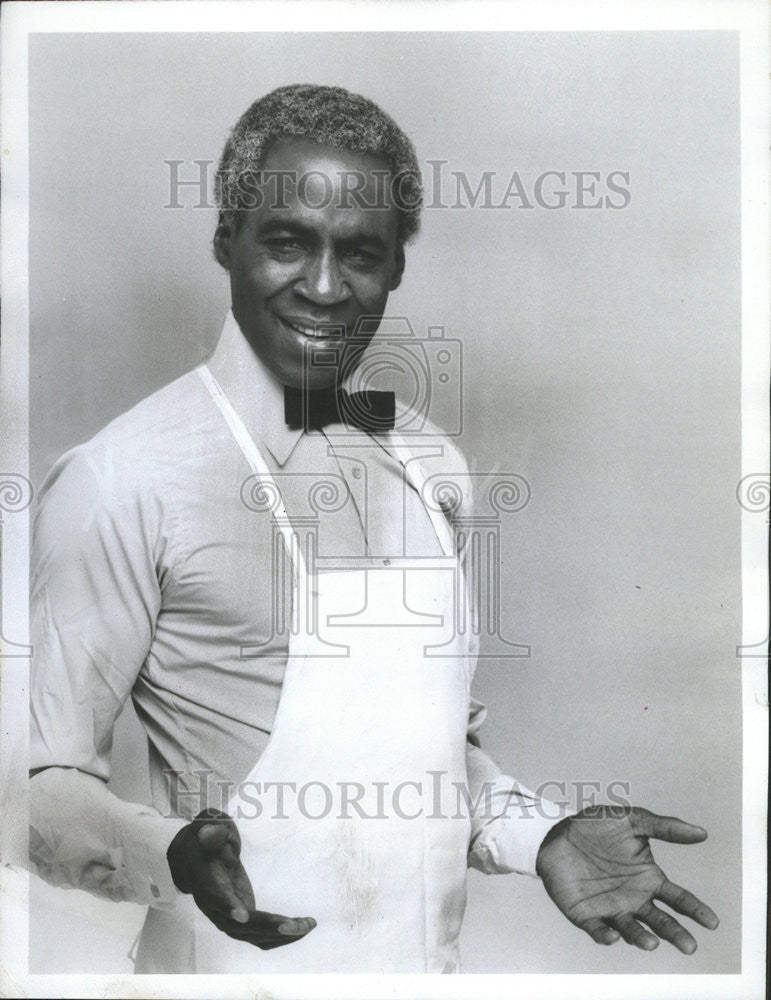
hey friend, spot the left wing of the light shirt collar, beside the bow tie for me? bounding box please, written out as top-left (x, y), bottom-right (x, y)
top-left (207, 310), bottom-right (303, 465)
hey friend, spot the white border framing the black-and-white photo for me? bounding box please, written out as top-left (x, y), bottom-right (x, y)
top-left (0, 0), bottom-right (769, 1000)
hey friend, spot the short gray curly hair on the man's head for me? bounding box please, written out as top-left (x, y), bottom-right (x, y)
top-left (216, 83), bottom-right (423, 244)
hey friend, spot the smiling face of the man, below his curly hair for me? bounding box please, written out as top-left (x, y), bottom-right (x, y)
top-left (214, 138), bottom-right (404, 389)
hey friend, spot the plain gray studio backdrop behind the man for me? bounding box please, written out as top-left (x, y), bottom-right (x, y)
top-left (30, 32), bottom-right (741, 973)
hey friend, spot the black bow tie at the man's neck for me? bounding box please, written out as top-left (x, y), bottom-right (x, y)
top-left (284, 385), bottom-right (396, 432)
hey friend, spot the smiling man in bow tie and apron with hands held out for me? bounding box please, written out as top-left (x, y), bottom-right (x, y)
top-left (30, 86), bottom-right (717, 972)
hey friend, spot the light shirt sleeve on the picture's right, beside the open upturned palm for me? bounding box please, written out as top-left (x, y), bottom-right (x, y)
top-left (466, 699), bottom-right (570, 876)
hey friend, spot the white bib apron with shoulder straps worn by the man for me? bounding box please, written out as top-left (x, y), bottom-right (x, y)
top-left (136, 366), bottom-right (473, 973)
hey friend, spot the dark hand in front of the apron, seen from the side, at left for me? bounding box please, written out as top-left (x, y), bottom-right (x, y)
top-left (166, 809), bottom-right (316, 951)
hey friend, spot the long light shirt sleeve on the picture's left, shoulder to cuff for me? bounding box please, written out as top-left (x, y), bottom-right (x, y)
top-left (30, 445), bottom-right (184, 906)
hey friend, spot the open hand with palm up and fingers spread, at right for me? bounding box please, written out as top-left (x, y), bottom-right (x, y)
top-left (536, 806), bottom-right (719, 955)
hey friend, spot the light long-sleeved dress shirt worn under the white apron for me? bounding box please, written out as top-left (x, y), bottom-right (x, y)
top-left (30, 314), bottom-right (561, 907)
